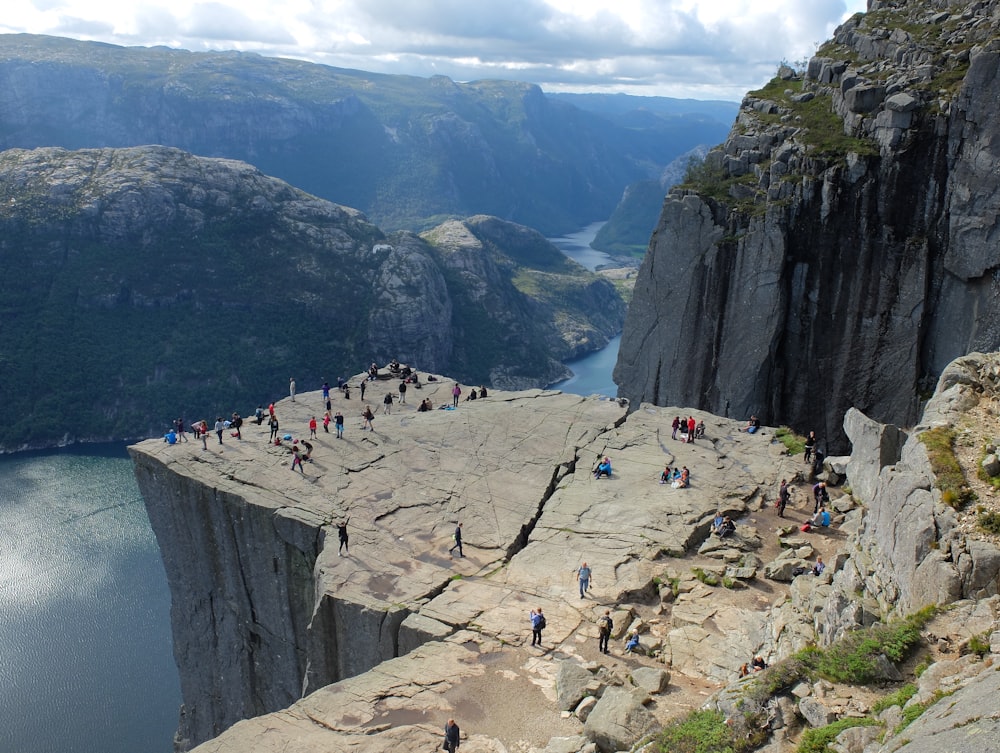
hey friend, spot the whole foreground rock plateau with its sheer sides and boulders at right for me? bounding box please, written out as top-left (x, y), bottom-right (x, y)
top-left (130, 354), bottom-right (1000, 753)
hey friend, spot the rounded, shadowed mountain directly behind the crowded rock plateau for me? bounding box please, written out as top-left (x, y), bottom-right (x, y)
top-left (0, 147), bottom-right (624, 449)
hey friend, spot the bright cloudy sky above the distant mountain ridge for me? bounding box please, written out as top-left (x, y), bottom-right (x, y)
top-left (0, 0), bottom-right (867, 100)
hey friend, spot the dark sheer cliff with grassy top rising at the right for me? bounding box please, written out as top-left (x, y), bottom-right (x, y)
top-left (615, 2), bottom-right (1000, 451)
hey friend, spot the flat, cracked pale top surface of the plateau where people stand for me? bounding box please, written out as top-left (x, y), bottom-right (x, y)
top-left (133, 378), bottom-right (833, 751)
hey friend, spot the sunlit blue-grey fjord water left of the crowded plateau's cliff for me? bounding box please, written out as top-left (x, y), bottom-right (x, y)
top-left (0, 444), bottom-right (181, 753)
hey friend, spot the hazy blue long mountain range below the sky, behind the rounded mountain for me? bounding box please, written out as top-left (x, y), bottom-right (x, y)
top-left (0, 35), bottom-right (726, 235)
